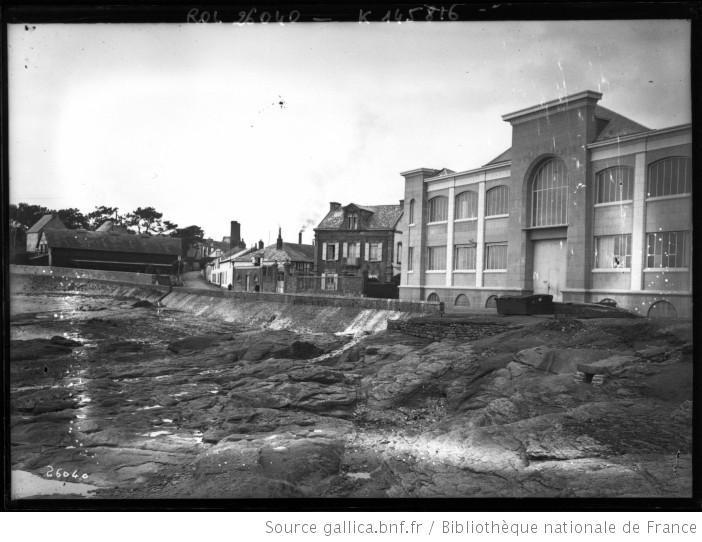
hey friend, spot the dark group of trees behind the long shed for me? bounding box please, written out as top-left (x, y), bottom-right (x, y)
top-left (9, 203), bottom-right (205, 242)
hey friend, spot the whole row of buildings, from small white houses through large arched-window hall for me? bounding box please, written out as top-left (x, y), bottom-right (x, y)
top-left (211, 90), bottom-right (693, 316)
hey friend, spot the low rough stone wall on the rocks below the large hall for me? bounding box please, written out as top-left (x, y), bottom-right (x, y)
top-left (387, 317), bottom-right (515, 341)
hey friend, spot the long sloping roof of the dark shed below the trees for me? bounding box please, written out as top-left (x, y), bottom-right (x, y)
top-left (44, 230), bottom-right (181, 256)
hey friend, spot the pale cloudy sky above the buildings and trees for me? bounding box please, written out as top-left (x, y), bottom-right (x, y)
top-left (8, 20), bottom-right (691, 245)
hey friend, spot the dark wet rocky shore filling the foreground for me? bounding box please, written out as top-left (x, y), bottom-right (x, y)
top-left (11, 280), bottom-right (692, 498)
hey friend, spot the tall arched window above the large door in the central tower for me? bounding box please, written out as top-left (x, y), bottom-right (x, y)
top-left (529, 158), bottom-right (568, 226)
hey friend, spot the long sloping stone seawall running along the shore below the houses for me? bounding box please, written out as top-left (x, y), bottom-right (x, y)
top-left (10, 265), bottom-right (438, 335)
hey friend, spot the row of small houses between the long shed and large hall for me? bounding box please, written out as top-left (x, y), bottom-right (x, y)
top-left (208, 201), bottom-right (404, 297)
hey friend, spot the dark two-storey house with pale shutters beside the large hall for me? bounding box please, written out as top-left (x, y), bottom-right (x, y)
top-left (314, 200), bottom-right (404, 293)
